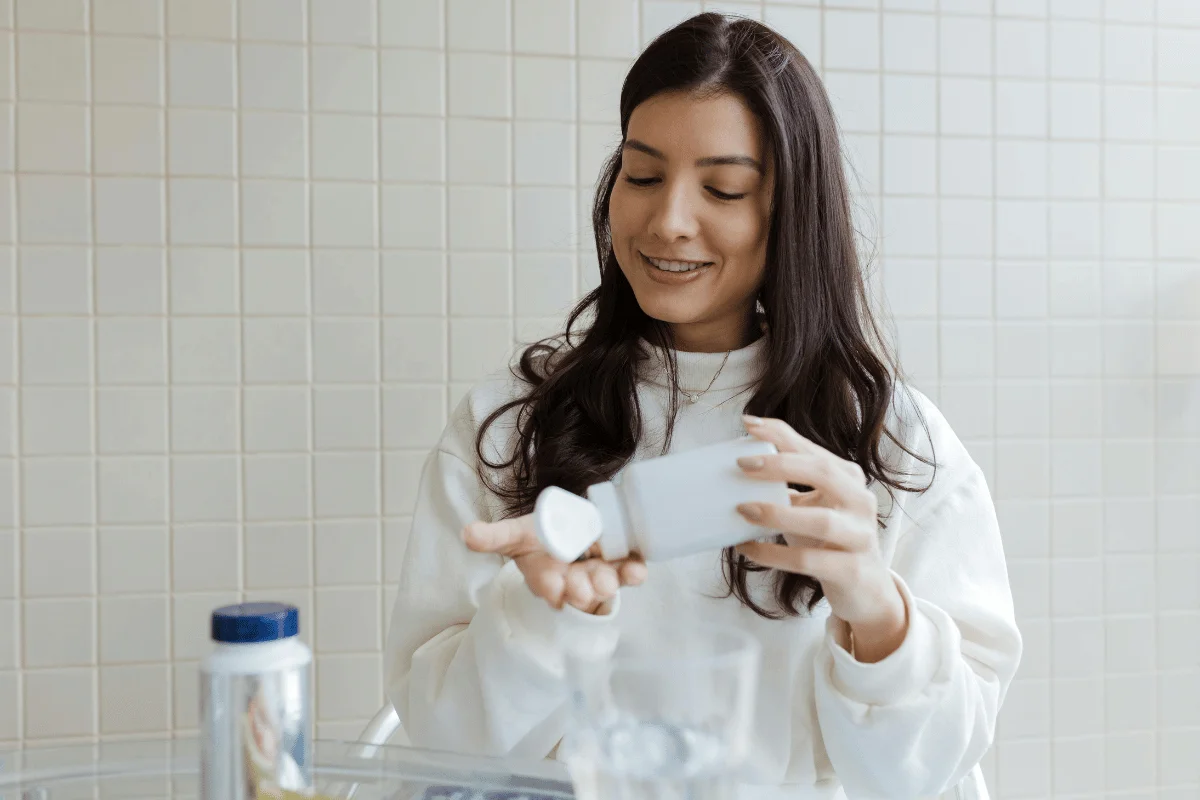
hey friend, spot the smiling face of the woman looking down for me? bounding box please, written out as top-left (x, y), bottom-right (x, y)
top-left (608, 92), bottom-right (772, 351)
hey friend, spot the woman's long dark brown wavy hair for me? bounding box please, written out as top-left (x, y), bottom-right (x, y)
top-left (475, 13), bottom-right (931, 619)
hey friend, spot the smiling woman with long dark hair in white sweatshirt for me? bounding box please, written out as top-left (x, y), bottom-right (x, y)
top-left (388, 14), bottom-right (1021, 798)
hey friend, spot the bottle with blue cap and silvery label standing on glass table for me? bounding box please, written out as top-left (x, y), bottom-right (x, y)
top-left (200, 602), bottom-right (312, 800)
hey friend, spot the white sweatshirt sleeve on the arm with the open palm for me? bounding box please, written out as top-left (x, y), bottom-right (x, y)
top-left (385, 388), bottom-right (620, 758)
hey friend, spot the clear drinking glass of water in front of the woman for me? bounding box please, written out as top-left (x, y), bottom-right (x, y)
top-left (562, 626), bottom-right (761, 800)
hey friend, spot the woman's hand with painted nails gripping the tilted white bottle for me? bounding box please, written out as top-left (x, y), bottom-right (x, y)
top-left (737, 416), bottom-right (907, 662)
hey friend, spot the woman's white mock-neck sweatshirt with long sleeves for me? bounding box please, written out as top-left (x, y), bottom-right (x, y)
top-left (385, 339), bottom-right (1021, 800)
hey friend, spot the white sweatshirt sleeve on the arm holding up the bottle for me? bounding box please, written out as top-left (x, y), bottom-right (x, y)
top-left (815, 393), bottom-right (1021, 799)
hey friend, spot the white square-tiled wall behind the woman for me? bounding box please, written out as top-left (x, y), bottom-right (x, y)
top-left (0, 0), bottom-right (1200, 800)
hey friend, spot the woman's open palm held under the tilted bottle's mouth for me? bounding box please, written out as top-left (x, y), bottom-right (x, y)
top-left (462, 515), bottom-right (646, 614)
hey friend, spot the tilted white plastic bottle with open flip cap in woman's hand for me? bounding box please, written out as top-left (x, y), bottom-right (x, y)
top-left (534, 437), bottom-right (790, 561)
